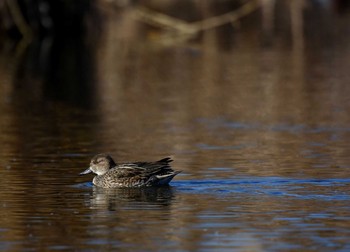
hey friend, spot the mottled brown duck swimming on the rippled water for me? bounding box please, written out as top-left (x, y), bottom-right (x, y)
top-left (79, 153), bottom-right (181, 188)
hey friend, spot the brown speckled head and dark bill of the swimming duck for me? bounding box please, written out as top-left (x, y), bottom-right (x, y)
top-left (80, 154), bottom-right (116, 175)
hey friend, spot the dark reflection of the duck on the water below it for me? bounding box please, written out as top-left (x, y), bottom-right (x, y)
top-left (90, 186), bottom-right (175, 211)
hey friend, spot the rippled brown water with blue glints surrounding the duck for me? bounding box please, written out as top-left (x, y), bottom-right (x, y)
top-left (0, 2), bottom-right (350, 251)
